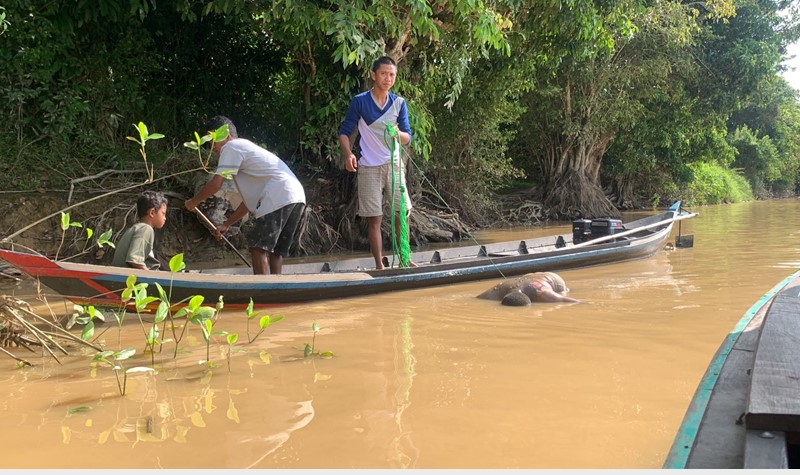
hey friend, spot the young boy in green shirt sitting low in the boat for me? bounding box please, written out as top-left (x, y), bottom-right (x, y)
top-left (112, 191), bottom-right (167, 270)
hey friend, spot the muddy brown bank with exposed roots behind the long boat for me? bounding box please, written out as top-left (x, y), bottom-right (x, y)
top-left (0, 190), bottom-right (478, 267)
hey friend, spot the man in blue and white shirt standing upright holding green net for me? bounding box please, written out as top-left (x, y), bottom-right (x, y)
top-left (339, 56), bottom-right (411, 269)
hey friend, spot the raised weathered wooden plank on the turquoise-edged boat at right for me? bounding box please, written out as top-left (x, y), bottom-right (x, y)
top-left (745, 279), bottom-right (800, 432)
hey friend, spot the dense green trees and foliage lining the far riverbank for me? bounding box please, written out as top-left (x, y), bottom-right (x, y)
top-left (0, 0), bottom-right (800, 223)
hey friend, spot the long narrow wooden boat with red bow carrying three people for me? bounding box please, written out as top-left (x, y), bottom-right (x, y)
top-left (0, 202), bottom-right (696, 308)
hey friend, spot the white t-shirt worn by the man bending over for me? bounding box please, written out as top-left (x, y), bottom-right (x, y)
top-left (216, 139), bottom-right (306, 218)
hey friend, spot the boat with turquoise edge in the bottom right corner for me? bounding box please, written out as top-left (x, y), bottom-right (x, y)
top-left (663, 271), bottom-right (800, 469)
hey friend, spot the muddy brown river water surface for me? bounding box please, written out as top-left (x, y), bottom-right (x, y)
top-left (0, 200), bottom-right (800, 469)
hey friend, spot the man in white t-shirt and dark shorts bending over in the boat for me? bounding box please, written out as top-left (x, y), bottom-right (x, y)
top-left (185, 115), bottom-right (306, 274)
